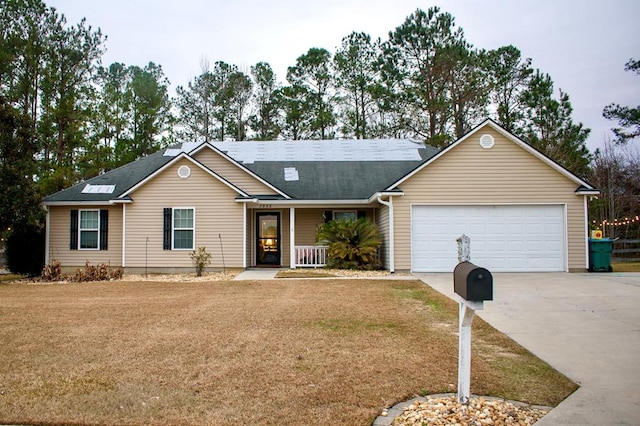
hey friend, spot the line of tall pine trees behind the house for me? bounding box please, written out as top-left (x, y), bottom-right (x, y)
top-left (0, 0), bottom-right (636, 272)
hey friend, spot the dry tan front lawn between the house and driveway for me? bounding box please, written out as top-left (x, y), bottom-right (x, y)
top-left (0, 279), bottom-right (576, 425)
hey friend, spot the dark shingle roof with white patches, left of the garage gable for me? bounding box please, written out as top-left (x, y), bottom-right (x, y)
top-left (44, 140), bottom-right (439, 204)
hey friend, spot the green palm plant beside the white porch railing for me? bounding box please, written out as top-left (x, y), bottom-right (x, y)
top-left (317, 218), bottom-right (382, 269)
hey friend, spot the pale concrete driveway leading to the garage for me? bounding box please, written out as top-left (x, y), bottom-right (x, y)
top-left (414, 272), bottom-right (640, 426)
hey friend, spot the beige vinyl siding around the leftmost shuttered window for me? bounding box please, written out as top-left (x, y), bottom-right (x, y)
top-left (49, 205), bottom-right (122, 270)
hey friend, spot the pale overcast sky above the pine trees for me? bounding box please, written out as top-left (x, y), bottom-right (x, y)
top-left (50, 0), bottom-right (640, 150)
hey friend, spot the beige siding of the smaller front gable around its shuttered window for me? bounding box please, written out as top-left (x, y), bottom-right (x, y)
top-left (126, 159), bottom-right (244, 269)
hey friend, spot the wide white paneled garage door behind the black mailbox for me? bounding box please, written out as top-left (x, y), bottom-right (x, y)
top-left (411, 205), bottom-right (566, 272)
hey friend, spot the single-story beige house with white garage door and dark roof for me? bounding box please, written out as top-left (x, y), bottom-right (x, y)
top-left (43, 120), bottom-right (598, 272)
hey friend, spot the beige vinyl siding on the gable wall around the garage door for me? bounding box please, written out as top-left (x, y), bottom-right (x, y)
top-left (394, 126), bottom-right (586, 270)
